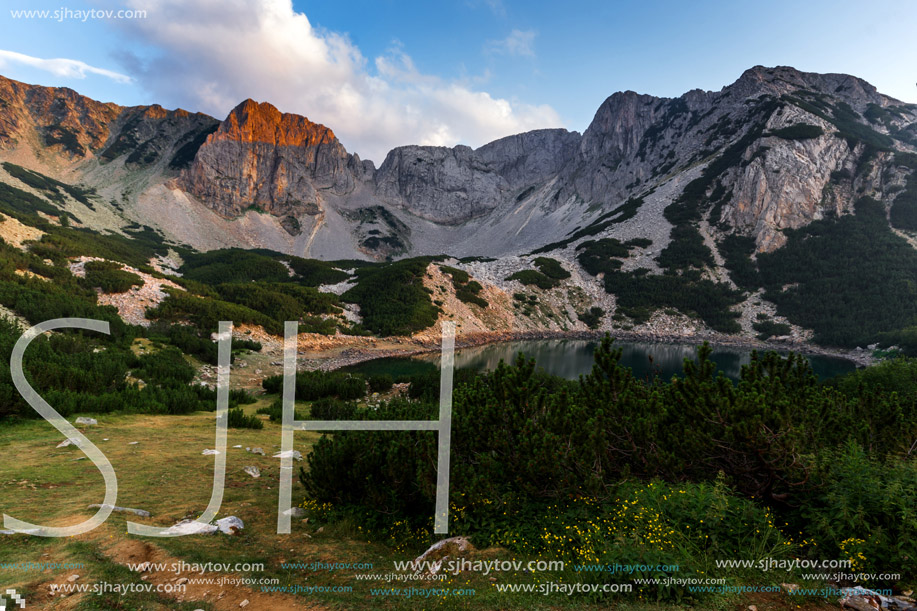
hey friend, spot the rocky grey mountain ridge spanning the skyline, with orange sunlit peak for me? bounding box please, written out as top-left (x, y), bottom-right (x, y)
top-left (0, 66), bottom-right (917, 258)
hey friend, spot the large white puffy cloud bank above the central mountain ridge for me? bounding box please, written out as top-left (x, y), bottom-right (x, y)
top-left (100, 0), bottom-right (561, 163)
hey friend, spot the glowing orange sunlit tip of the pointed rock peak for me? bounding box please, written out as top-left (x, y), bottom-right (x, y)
top-left (212, 98), bottom-right (337, 147)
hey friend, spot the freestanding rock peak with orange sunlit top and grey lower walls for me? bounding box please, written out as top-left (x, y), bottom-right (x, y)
top-left (181, 100), bottom-right (362, 230)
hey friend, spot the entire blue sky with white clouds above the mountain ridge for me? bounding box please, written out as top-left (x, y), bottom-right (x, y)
top-left (0, 0), bottom-right (917, 163)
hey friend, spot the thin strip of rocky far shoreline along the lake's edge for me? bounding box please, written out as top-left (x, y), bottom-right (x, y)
top-left (307, 330), bottom-right (874, 371)
